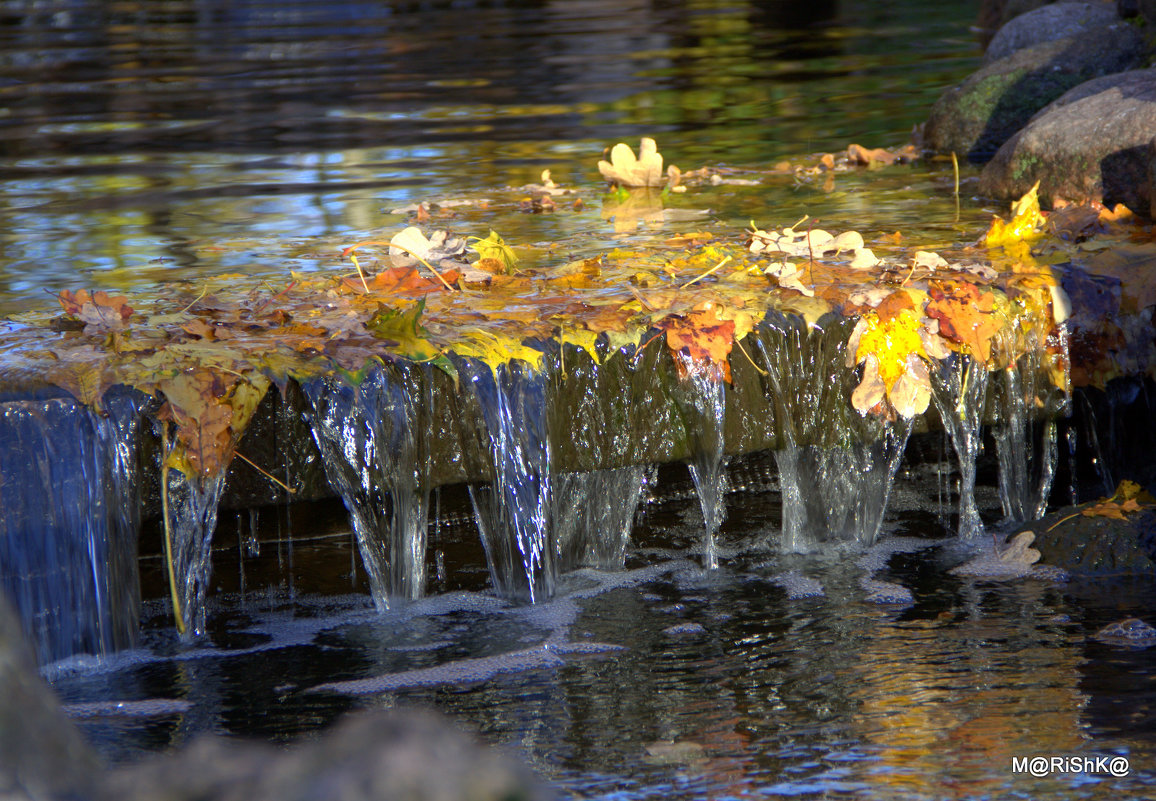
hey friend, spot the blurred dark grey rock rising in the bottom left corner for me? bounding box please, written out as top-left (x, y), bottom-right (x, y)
top-left (0, 598), bottom-right (102, 801)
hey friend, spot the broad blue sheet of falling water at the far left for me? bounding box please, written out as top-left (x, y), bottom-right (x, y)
top-left (0, 395), bottom-right (143, 663)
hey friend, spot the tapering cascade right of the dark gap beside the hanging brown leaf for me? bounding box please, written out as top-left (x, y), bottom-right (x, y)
top-left (304, 366), bottom-right (432, 609)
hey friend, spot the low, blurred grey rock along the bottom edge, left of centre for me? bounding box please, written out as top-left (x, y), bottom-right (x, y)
top-left (96, 711), bottom-right (550, 801)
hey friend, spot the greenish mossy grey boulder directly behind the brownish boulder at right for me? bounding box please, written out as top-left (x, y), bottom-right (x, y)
top-left (924, 22), bottom-right (1147, 162)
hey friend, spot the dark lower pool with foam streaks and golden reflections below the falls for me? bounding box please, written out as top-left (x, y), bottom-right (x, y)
top-left (49, 446), bottom-right (1156, 799)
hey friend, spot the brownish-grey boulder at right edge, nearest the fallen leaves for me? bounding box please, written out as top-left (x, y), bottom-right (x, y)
top-left (979, 69), bottom-right (1156, 214)
